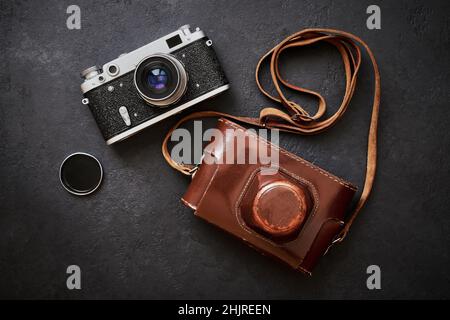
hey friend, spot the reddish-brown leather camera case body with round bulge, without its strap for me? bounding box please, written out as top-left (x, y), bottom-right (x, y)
top-left (183, 118), bottom-right (356, 274)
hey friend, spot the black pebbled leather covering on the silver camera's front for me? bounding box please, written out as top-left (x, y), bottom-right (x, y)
top-left (84, 37), bottom-right (228, 140)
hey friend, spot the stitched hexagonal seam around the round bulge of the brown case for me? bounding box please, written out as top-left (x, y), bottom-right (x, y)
top-left (234, 168), bottom-right (319, 254)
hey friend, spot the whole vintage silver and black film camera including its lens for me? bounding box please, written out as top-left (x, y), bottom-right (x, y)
top-left (81, 25), bottom-right (229, 145)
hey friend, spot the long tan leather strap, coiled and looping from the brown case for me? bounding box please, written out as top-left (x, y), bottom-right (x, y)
top-left (162, 29), bottom-right (381, 242)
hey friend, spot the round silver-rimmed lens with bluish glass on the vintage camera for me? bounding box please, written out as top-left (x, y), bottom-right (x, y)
top-left (134, 54), bottom-right (187, 107)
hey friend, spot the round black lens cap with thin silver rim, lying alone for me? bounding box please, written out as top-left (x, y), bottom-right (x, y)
top-left (59, 152), bottom-right (103, 196)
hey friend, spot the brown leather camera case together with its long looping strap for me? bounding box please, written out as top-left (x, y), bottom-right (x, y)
top-left (162, 29), bottom-right (381, 274)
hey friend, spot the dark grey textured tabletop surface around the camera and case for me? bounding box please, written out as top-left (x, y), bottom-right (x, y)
top-left (0, 0), bottom-right (450, 299)
